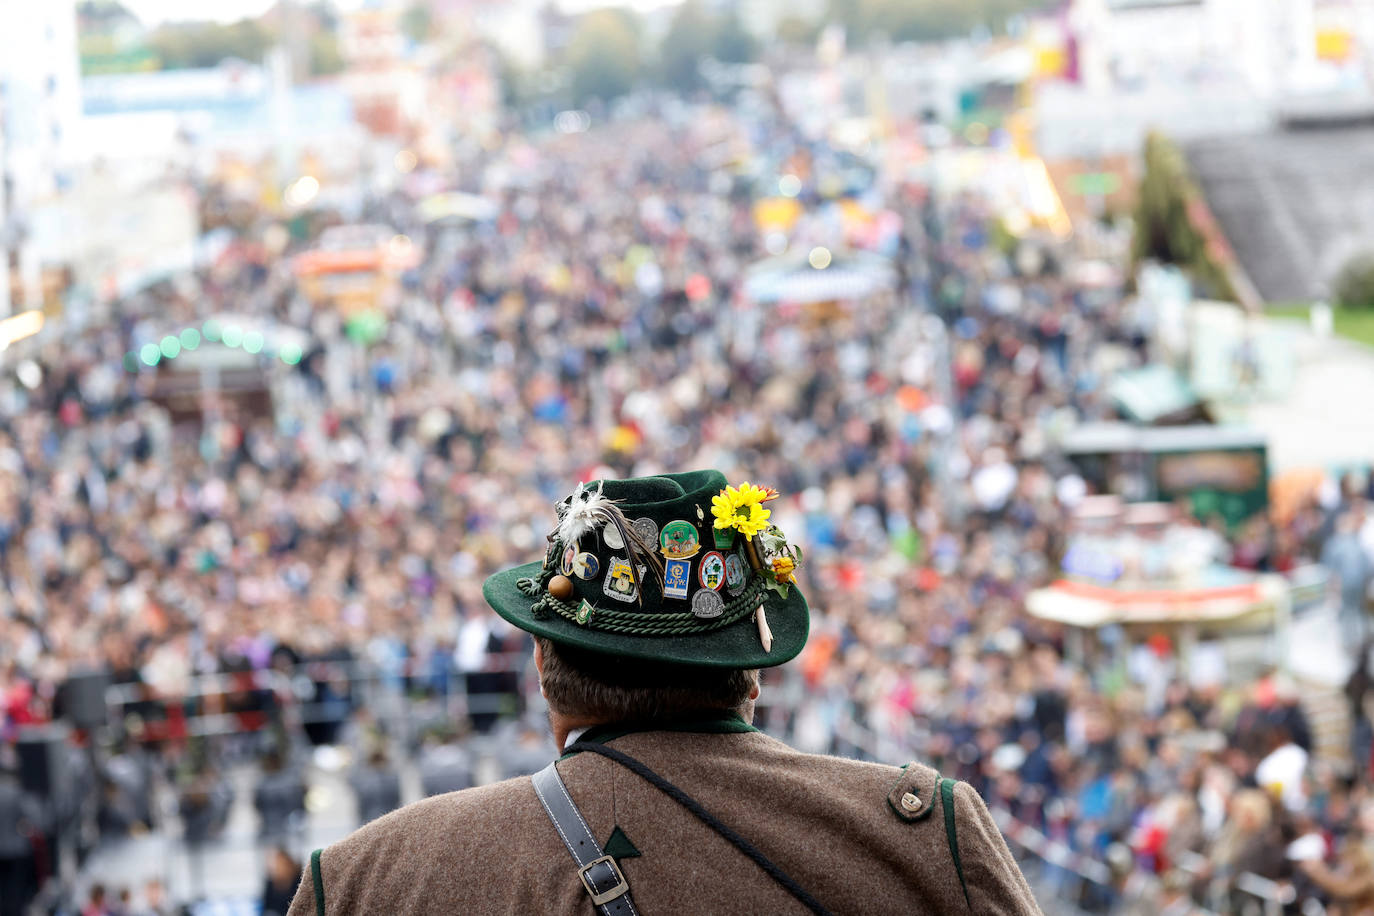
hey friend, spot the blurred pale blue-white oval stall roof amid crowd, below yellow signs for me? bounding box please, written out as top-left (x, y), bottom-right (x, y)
top-left (745, 247), bottom-right (897, 305)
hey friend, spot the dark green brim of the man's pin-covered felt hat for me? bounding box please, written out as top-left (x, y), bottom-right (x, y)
top-left (482, 563), bottom-right (811, 669)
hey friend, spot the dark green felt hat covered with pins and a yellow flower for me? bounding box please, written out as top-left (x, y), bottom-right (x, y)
top-left (482, 471), bottom-right (811, 669)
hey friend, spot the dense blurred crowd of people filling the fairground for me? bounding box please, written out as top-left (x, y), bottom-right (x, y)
top-left (0, 94), bottom-right (1374, 913)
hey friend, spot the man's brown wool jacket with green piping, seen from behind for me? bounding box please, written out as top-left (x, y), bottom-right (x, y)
top-left (289, 720), bottom-right (1040, 916)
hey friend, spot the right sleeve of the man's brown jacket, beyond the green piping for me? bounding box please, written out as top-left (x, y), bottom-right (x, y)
top-left (956, 783), bottom-right (1043, 916)
